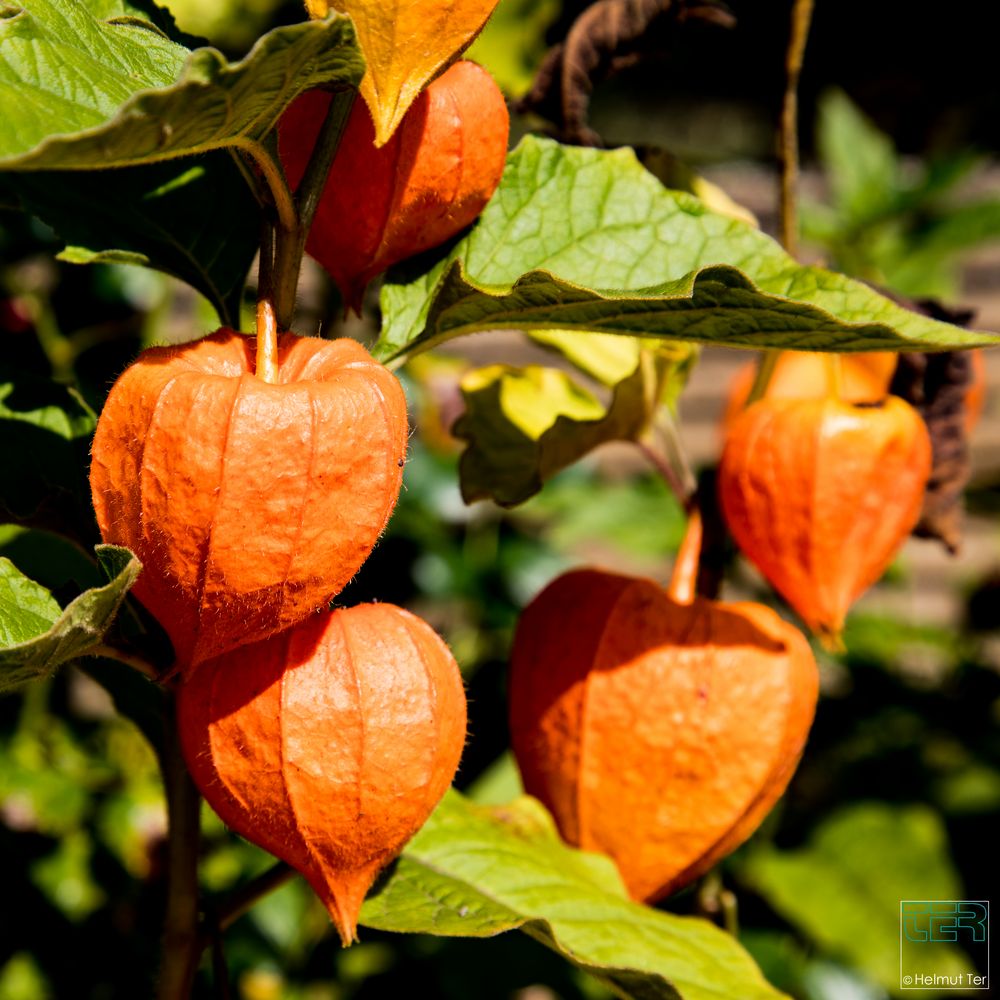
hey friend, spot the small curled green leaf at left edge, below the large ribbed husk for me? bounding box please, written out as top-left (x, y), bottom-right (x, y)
top-left (0, 545), bottom-right (142, 691)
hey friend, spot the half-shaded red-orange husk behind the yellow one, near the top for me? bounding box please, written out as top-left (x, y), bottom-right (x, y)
top-left (278, 61), bottom-right (510, 309)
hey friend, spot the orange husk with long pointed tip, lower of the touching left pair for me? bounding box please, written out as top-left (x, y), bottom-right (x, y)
top-left (177, 604), bottom-right (466, 945)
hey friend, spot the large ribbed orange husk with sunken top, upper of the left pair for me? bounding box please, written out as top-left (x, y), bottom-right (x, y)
top-left (90, 329), bottom-right (407, 670)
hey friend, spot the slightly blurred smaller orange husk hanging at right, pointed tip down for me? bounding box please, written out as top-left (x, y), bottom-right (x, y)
top-left (718, 396), bottom-right (931, 640)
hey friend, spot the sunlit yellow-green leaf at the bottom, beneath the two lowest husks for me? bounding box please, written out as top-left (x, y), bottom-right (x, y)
top-left (361, 792), bottom-right (781, 1000)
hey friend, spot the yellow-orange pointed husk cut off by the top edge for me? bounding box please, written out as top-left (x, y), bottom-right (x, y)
top-left (306, 0), bottom-right (498, 146)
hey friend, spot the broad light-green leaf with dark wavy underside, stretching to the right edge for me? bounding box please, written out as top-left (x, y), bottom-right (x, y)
top-left (375, 137), bottom-right (995, 361)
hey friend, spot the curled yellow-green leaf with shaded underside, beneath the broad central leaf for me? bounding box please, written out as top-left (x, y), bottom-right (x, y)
top-left (451, 358), bottom-right (658, 507)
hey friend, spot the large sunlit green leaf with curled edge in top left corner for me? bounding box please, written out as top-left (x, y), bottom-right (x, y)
top-left (0, 8), bottom-right (364, 170)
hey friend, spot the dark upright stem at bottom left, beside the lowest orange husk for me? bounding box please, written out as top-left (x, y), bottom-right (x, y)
top-left (156, 696), bottom-right (203, 1000)
